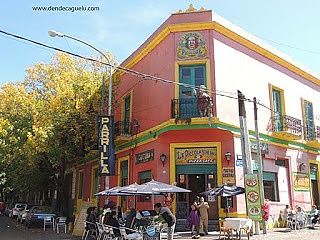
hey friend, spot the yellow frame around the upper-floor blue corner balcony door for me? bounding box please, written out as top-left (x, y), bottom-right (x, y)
top-left (174, 58), bottom-right (212, 98)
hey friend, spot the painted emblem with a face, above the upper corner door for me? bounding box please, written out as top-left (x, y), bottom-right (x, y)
top-left (177, 32), bottom-right (208, 59)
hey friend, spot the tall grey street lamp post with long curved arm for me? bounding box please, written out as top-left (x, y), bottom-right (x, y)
top-left (48, 30), bottom-right (112, 210)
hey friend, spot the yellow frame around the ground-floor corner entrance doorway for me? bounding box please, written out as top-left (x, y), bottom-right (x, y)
top-left (169, 142), bottom-right (224, 216)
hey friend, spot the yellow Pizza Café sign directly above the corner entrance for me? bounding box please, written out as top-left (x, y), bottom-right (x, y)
top-left (175, 147), bottom-right (217, 164)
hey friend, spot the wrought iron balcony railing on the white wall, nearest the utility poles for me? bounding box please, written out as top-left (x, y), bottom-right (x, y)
top-left (267, 115), bottom-right (302, 136)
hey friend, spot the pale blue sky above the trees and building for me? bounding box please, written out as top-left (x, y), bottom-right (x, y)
top-left (0, 0), bottom-right (320, 84)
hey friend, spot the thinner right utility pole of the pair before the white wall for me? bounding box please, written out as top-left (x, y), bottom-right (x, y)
top-left (253, 97), bottom-right (267, 234)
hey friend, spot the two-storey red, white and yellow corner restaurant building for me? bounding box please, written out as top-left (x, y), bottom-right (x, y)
top-left (76, 7), bottom-right (320, 223)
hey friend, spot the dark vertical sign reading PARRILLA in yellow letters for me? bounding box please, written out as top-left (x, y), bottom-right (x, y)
top-left (98, 116), bottom-right (115, 176)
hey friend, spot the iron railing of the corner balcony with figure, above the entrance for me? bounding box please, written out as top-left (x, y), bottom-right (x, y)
top-left (171, 98), bottom-right (213, 119)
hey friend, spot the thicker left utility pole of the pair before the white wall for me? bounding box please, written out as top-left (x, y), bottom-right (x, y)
top-left (238, 90), bottom-right (259, 234)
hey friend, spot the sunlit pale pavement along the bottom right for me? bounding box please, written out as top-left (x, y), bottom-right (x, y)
top-left (174, 227), bottom-right (320, 240)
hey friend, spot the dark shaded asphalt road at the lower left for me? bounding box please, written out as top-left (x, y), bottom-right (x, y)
top-left (0, 215), bottom-right (79, 240)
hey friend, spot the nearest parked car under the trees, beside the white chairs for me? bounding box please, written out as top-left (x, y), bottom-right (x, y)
top-left (25, 206), bottom-right (56, 227)
